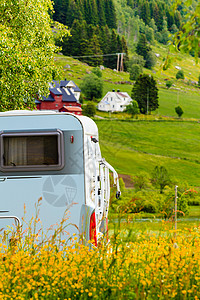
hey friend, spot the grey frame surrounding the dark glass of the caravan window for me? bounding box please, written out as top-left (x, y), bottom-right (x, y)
top-left (0, 129), bottom-right (64, 172)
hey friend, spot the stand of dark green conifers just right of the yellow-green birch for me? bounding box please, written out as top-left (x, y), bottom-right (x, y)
top-left (53, 0), bottom-right (128, 70)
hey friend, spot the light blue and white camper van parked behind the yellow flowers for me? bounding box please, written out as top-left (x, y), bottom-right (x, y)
top-left (0, 111), bottom-right (120, 245)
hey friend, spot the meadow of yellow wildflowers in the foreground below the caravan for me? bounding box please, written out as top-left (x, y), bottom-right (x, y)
top-left (0, 214), bottom-right (200, 300)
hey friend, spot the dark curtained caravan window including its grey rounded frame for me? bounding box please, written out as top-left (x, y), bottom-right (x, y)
top-left (1, 130), bottom-right (63, 171)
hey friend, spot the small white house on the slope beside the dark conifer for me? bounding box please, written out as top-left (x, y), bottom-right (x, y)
top-left (97, 90), bottom-right (132, 112)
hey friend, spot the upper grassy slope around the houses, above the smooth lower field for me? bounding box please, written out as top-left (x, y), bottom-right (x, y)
top-left (55, 44), bottom-right (200, 118)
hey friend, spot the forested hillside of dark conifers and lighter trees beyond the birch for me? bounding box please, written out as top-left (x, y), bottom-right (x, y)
top-left (53, 0), bottom-right (197, 70)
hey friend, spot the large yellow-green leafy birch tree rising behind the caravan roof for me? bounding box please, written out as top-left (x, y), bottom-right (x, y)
top-left (0, 0), bottom-right (69, 111)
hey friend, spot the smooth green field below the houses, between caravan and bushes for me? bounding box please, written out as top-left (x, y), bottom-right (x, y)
top-left (95, 119), bottom-right (200, 186)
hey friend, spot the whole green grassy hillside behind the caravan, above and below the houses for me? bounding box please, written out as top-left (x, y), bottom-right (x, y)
top-left (55, 49), bottom-right (200, 186)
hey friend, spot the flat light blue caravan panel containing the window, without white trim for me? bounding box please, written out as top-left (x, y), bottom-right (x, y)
top-left (0, 114), bottom-right (85, 240)
